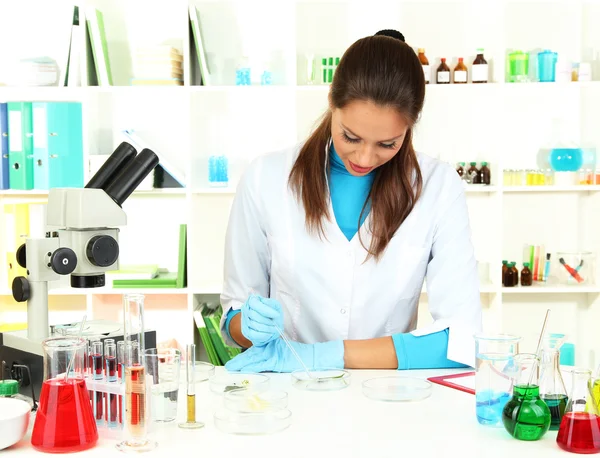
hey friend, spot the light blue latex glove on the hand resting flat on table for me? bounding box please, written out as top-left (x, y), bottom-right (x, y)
top-left (225, 339), bottom-right (344, 372)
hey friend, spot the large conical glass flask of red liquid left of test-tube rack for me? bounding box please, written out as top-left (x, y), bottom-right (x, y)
top-left (31, 337), bottom-right (98, 453)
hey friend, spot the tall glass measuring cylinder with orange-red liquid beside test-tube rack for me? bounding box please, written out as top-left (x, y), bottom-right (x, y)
top-left (117, 294), bottom-right (157, 452)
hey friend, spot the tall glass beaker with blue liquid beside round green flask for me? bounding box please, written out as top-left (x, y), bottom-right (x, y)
top-left (475, 334), bottom-right (521, 426)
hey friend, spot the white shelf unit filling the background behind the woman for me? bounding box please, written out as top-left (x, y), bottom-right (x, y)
top-left (0, 0), bottom-right (600, 367)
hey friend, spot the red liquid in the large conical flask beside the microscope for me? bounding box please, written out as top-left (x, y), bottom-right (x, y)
top-left (31, 377), bottom-right (98, 453)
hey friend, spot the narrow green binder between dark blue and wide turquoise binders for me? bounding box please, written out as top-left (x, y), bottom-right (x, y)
top-left (8, 102), bottom-right (33, 190)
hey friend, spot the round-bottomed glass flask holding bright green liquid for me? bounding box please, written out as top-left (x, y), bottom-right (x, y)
top-left (502, 353), bottom-right (551, 441)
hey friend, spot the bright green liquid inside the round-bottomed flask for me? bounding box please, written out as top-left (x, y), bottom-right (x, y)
top-left (502, 385), bottom-right (551, 441)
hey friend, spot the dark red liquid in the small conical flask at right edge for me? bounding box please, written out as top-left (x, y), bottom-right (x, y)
top-left (556, 412), bottom-right (600, 453)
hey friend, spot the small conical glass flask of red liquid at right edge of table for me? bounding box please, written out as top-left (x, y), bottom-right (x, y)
top-left (556, 369), bottom-right (600, 453)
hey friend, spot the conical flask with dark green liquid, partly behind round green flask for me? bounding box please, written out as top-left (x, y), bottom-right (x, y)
top-left (540, 348), bottom-right (567, 431)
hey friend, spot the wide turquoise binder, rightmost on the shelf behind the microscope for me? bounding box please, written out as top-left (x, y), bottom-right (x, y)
top-left (33, 102), bottom-right (83, 189)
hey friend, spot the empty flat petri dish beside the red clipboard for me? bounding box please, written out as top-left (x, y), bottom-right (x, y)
top-left (363, 376), bottom-right (432, 402)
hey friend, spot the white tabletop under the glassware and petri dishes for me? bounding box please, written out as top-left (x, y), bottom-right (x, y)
top-left (0, 368), bottom-right (574, 458)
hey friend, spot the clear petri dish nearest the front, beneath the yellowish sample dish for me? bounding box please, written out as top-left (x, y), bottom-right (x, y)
top-left (214, 409), bottom-right (292, 436)
